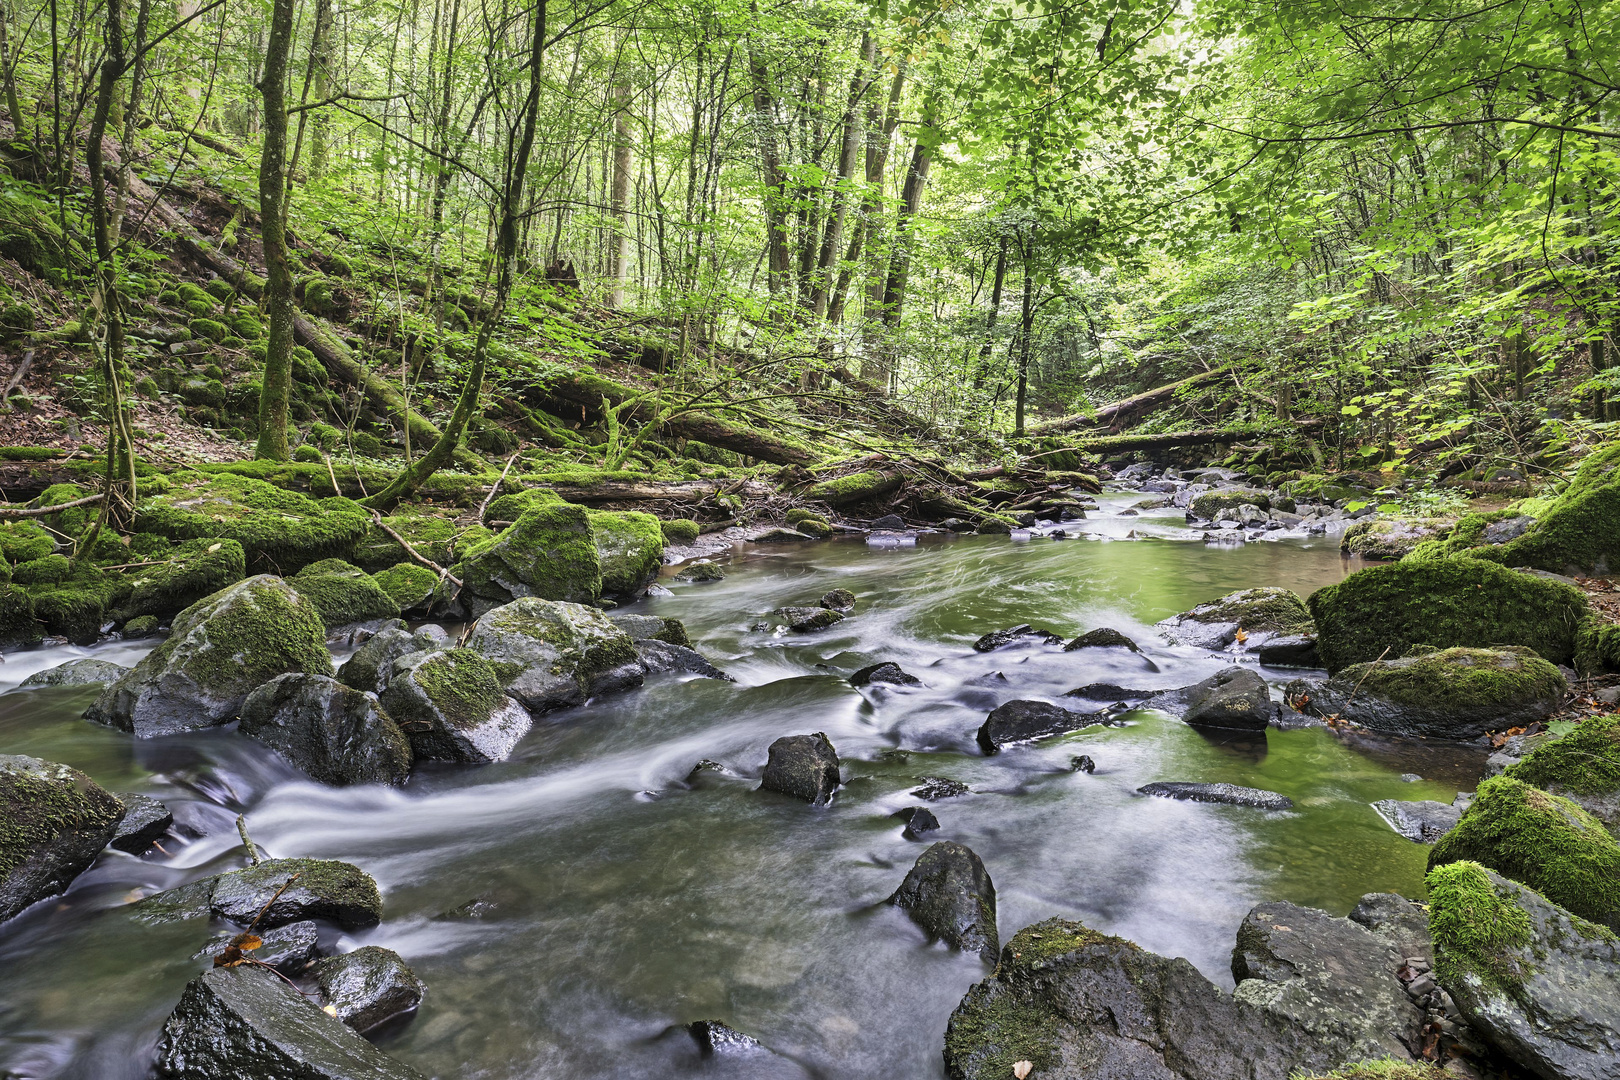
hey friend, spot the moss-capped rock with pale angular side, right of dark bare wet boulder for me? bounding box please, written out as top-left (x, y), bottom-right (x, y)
top-left (381, 649), bottom-right (533, 764)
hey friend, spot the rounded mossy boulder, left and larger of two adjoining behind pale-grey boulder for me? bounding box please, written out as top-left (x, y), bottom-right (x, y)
top-left (455, 504), bottom-right (603, 617)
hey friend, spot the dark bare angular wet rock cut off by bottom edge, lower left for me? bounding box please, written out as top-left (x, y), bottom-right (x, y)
top-left (157, 965), bottom-right (421, 1080)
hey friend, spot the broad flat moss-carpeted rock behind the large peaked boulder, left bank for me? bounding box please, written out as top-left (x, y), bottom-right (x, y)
top-left (134, 473), bottom-right (371, 573)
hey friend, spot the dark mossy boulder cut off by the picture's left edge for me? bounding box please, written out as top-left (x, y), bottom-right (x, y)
top-left (0, 755), bottom-right (123, 923)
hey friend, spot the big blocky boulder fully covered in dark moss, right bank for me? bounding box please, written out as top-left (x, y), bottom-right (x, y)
top-left (1307, 559), bottom-right (1588, 672)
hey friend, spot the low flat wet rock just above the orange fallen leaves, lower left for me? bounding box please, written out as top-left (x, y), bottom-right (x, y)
top-left (134, 858), bottom-right (382, 929)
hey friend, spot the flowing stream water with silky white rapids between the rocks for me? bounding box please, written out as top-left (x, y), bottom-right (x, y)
top-left (0, 495), bottom-right (1482, 1080)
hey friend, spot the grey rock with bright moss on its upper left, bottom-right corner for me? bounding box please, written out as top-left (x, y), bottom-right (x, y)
top-left (1429, 861), bottom-right (1620, 1080)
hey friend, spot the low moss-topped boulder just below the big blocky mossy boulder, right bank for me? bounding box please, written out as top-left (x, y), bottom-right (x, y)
top-left (1304, 648), bottom-right (1568, 740)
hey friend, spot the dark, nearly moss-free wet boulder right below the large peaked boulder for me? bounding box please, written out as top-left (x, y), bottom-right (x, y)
top-left (237, 674), bottom-right (411, 785)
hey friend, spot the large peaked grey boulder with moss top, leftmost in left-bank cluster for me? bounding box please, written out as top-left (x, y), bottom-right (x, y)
top-left (84, 575), bottom-right (332, 738)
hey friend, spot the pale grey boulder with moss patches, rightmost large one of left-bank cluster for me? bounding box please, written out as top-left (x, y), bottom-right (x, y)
top-left (467, 597), bottom-right (646, 712)
